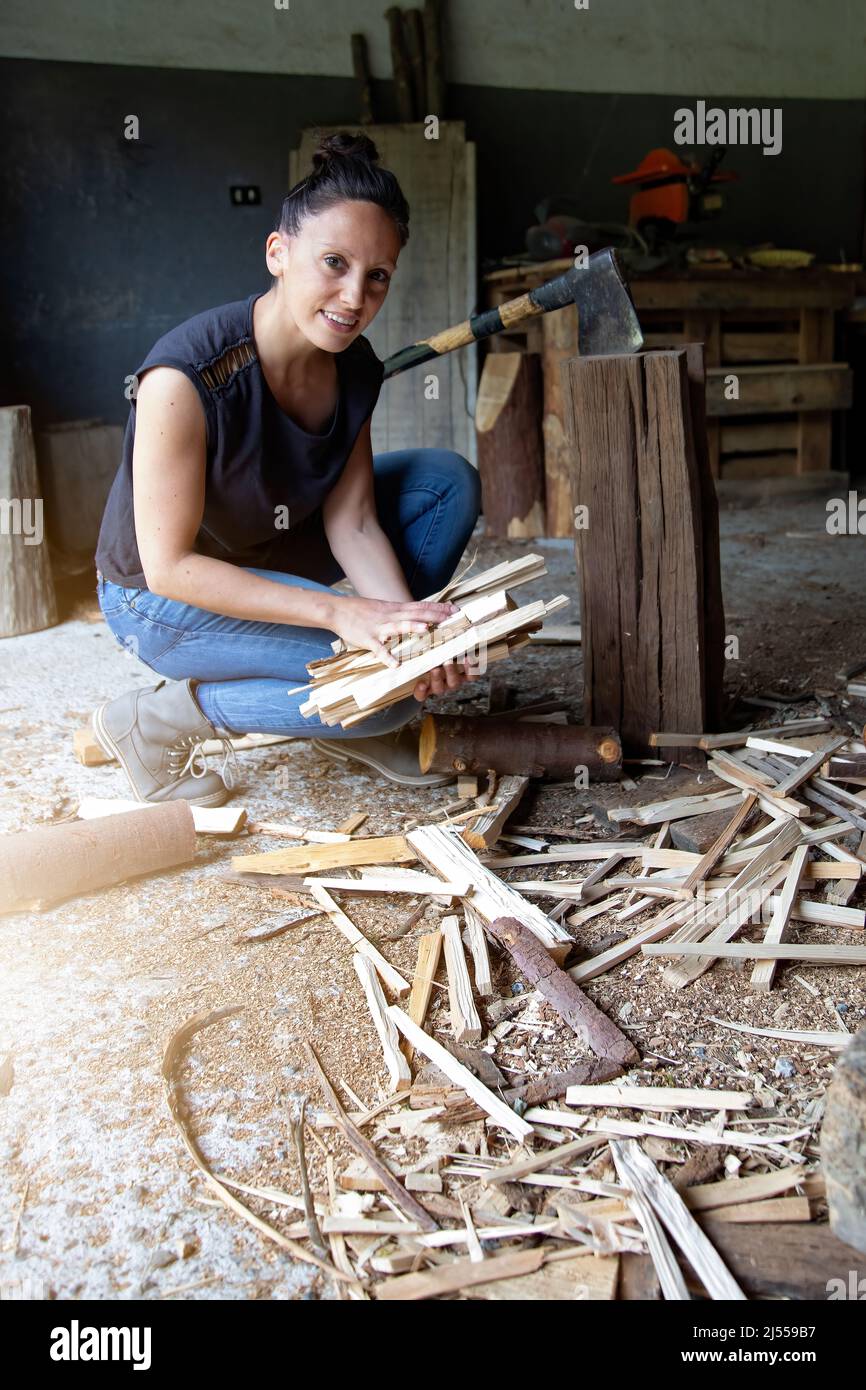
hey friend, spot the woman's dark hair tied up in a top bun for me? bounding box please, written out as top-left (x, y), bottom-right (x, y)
top-left (277, 131), bottom-right (409, 246)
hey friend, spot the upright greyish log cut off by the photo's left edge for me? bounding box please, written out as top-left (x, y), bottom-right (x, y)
top-left (0, 406), bottom-right (57, 637)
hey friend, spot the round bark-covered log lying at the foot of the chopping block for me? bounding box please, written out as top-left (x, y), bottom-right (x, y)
top-left (418, 714), bottom-right (623, 781)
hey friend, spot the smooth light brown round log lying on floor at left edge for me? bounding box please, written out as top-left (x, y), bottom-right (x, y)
top-left (0, 801), bottom-right (196, 913)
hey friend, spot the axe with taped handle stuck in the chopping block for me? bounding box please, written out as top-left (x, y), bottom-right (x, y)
top-left (385, 247), bottom-right (644, 378)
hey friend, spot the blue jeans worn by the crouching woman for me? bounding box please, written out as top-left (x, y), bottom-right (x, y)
top-left (99, 449), bottom-right (481, 738)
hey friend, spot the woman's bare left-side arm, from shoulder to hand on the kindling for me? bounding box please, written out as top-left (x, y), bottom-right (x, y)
top-left (132, 367), bottom-right (453, 663)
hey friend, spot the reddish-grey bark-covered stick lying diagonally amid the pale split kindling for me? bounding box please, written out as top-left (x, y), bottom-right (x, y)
top-left (488, 917), bottom-right (639, 1066)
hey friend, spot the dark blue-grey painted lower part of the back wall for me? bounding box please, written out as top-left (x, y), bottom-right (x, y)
top-left (0, 60), bottom-right (866, 424)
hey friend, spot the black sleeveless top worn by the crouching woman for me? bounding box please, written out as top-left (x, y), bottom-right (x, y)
top-left (96, 293), bottom-right (385, 588)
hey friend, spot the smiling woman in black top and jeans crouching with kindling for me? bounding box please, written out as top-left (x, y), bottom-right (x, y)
top-left (93, 133), bottom-right (480, 806)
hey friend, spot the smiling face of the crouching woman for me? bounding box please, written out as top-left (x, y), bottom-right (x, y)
top-left (267, 202), bottom-right (400, 352)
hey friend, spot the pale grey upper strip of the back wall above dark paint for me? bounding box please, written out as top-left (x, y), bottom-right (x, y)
top-left (6, 0), bottom-right (866, 100)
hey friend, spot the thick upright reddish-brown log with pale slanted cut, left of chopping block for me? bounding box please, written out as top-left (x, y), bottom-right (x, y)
top-left (475, 352), bottom-right (545, 539)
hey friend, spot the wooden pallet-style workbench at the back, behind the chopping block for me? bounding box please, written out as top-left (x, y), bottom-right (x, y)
top-left (485, 259), bottom-right (856, 522)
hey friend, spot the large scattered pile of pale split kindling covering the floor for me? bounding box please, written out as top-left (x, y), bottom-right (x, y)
top-left (167, 717), bottom-right (866, 1300)
